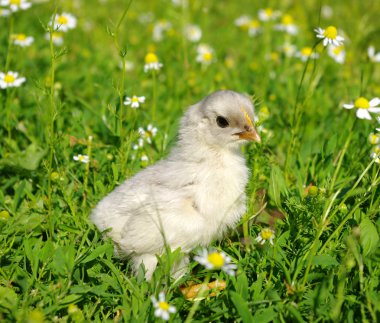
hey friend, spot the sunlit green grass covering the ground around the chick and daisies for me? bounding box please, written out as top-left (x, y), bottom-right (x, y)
top-left (0, 0), bottom-right (380, 322)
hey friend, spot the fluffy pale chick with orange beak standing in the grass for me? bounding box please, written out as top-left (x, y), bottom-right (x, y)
top-left (91, 90), bottom-right (260, 279)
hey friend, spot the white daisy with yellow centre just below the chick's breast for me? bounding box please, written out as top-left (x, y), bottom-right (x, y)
top-left (194, 248), bottom-right (237, 276)
